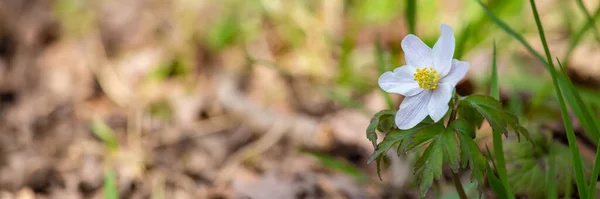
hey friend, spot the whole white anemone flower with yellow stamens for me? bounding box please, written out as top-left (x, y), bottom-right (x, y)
top-left (379, 24), bottom-right (469, 129)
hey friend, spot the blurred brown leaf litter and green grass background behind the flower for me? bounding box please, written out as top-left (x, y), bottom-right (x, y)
top-left (0, 0), bottom-right (600, 199)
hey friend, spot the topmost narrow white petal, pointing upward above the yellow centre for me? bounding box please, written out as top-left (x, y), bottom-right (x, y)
top-left (432, 24), bottom-right (455, 77)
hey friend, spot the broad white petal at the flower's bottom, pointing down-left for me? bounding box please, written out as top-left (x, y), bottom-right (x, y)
top-left (395, 91), bottom-right (431, 129)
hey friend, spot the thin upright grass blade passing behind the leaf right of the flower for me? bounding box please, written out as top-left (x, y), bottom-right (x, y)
top-left (490, 41), bottom-right (514, 198)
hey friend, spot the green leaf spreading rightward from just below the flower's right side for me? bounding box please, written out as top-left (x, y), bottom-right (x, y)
top-left (459, 95), bottom-right (529, 138)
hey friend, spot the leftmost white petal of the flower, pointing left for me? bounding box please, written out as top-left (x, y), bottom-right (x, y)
top-left (379, 65), bottom-right (423, 96)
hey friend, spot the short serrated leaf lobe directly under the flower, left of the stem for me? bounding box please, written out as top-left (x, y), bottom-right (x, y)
top-left (440, 128), bottom-right (460, 172)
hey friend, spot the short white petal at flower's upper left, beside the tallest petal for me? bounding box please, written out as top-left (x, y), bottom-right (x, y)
top-left (401, 34), bottom-right (433, 68)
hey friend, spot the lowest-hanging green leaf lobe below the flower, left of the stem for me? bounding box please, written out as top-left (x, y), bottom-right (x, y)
top-left (414, 140), bottom-right (443, 197)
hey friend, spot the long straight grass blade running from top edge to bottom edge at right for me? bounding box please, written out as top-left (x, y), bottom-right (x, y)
top-left (529, 0), bottom-right (587, 198)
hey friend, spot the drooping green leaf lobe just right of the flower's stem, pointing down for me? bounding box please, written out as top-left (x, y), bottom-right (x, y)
top-left (458, 133), bottom-right (487, 187)
